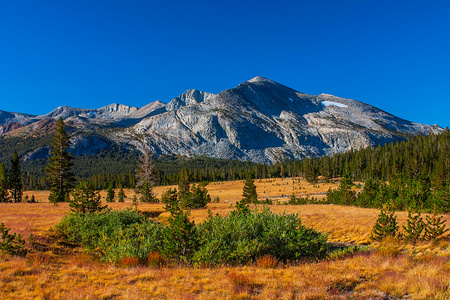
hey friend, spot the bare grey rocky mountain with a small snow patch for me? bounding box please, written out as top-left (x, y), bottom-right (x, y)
top-left (0, 76), bottom-right (443, 163)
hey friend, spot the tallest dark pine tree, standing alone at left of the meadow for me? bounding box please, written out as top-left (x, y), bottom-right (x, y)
top-left (45, 118), bottom-right (75, 205)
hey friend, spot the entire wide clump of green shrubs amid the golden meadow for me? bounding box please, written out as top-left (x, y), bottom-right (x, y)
top-left (55, 205), bottom-right (328, 267)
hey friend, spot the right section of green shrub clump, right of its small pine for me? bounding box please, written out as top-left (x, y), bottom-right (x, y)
top-left (193, 208), bottom-right (327, 265)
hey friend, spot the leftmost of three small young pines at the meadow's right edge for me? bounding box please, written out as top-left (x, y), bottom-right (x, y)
top-left (370, 204), bottom-right (398, 241)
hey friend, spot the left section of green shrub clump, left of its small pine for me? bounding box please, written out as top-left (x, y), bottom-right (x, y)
top-left (55, 209), bottom-right (164, 263)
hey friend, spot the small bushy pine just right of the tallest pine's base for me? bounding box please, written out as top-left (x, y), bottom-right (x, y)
top-left (69, 181), bottom-right (106, 213)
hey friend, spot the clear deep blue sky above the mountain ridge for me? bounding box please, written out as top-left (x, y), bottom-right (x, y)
top-left (0, 0), bottom-right (450, 127)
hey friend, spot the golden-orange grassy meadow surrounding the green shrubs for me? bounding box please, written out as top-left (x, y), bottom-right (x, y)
top-left (0, 179), bottom-right (450, 299)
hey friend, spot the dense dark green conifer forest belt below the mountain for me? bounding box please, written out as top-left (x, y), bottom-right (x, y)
top-left (0, 128), bottom-right (450, 212)
